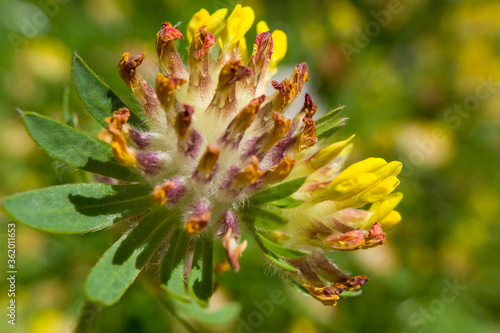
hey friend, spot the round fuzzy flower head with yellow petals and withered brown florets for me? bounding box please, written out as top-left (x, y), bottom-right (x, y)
top-left (1, 5), bottom-right (402, 305)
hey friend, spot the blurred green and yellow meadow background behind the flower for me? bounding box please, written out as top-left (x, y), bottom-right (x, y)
top-left (0, 0), bottom-right (500, 333)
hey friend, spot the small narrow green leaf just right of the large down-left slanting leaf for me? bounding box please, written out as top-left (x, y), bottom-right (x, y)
top-left (160, 228), bottom-right (190, 302)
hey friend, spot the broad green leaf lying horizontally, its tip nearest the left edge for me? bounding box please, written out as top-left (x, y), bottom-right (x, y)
top-left (1, 184), bottom-right (151, 233)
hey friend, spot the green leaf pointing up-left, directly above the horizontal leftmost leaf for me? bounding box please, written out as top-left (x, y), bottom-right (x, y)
top-left (21, 111), bottom-right (142, 181)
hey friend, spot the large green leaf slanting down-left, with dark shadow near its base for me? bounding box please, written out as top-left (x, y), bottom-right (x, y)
top-left (85, 209), bottom-right (172, 306)
